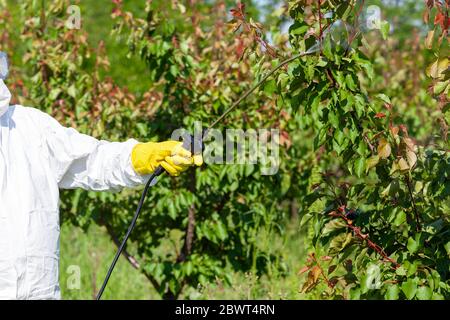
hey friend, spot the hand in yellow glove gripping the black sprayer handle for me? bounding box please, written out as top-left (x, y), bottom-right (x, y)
top-left (131, 140), bottom-right (203, 176)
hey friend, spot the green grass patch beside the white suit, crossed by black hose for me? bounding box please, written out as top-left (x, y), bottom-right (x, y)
top-left (60, 224), bottom-right (159, 300)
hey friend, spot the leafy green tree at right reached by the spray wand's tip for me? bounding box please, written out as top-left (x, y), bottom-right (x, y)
top-left (286, 1), bottom-right (450, 299)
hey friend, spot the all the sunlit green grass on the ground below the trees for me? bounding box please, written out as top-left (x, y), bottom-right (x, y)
top-left (60, 220), bottom-right (305, 300)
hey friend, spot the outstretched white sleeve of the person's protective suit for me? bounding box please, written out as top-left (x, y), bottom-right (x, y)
top-left (33, 111), bottom-right (149, 191)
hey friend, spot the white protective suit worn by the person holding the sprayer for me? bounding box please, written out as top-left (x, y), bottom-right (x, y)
top-left (0, 80), bottom-right (146, 299)
